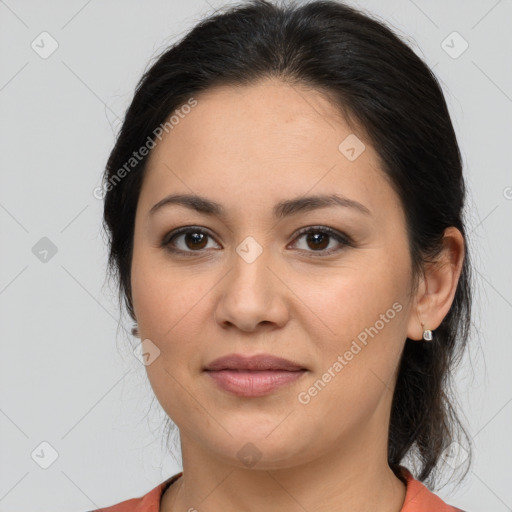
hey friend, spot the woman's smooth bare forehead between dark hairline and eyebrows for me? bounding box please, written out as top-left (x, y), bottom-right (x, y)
top-left (141, 80), bottom-right (396, 220)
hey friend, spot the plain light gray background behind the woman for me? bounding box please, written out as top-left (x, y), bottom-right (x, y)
top-left (0, 0), bottom-right (512, 512)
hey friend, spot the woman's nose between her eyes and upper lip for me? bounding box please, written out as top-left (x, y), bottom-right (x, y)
top-left (215, 243), bottom-right (289, 332)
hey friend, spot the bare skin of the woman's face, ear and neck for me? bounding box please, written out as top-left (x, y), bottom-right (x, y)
top-left (131, 79), bottom-right (463, 512)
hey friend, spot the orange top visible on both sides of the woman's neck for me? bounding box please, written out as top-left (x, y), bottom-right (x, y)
top-left (92, 466), bottom-right (464, 512)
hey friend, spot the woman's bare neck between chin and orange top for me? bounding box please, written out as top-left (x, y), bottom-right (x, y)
top-left (160, 439), bottom-right (406, 512)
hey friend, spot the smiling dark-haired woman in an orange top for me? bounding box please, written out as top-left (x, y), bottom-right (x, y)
top-left (91, 1), bottom-right (471, 512)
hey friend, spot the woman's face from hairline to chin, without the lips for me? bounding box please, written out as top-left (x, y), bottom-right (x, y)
top-left (131, 81), bottom-right (418, 469)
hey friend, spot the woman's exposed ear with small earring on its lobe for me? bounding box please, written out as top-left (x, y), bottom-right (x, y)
top-left (407, 226), bottom-right (464, 340)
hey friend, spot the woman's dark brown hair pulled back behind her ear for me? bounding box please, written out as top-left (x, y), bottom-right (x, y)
top-left (104, 0), bottom-right (472, 487)
